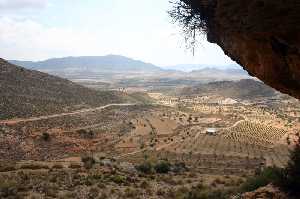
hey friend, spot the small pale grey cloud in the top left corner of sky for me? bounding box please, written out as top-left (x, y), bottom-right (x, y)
top-left (0, 0), bottom-right (48, 10)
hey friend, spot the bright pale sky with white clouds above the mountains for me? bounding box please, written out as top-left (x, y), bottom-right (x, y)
top-left (0, 0), bottom-right (234, 66)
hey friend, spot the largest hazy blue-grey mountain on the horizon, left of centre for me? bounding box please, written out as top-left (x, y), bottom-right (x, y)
top-left (9, 55), bottom-right (161, 72)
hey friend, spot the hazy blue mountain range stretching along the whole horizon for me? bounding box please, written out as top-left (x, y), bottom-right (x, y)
top-left (9, 55), bottom-right (249, 84)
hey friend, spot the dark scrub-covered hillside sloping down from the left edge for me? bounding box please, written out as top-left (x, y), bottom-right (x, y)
top-left (0, 59), bottom-right (122, 119)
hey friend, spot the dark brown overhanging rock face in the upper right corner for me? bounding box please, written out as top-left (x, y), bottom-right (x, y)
top-left (199, 0), bottom-right (300, 99)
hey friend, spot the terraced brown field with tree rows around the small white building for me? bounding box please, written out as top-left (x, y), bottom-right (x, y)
top-left (121, 112), bottom-right (289, 174)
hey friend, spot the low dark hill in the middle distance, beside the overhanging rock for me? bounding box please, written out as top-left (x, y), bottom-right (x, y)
top-left (181, 79), bottom-right (276, 99)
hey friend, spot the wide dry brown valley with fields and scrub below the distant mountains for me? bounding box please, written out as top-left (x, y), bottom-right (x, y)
top-left (0, 58), bottom-right (300, 199)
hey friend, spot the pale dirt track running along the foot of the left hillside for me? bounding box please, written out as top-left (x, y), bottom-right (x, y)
top-left (0, 104), bottom-right (136, 125)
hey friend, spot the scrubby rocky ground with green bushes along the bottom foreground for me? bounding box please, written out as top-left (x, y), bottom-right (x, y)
top-left (0, 157), bottom-right (244, 199)
